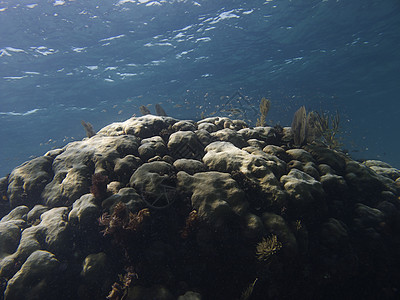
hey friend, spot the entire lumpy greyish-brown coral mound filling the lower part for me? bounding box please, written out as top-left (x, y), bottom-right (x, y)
top-left (0, 115), bottom-right (400, 300)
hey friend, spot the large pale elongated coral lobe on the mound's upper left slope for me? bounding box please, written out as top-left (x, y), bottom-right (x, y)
top-left (42, 135), bottom-right (139, 207)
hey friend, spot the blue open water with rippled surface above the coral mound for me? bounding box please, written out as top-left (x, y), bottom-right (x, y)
top-left (0, 0), bottom-right (400, 176)
